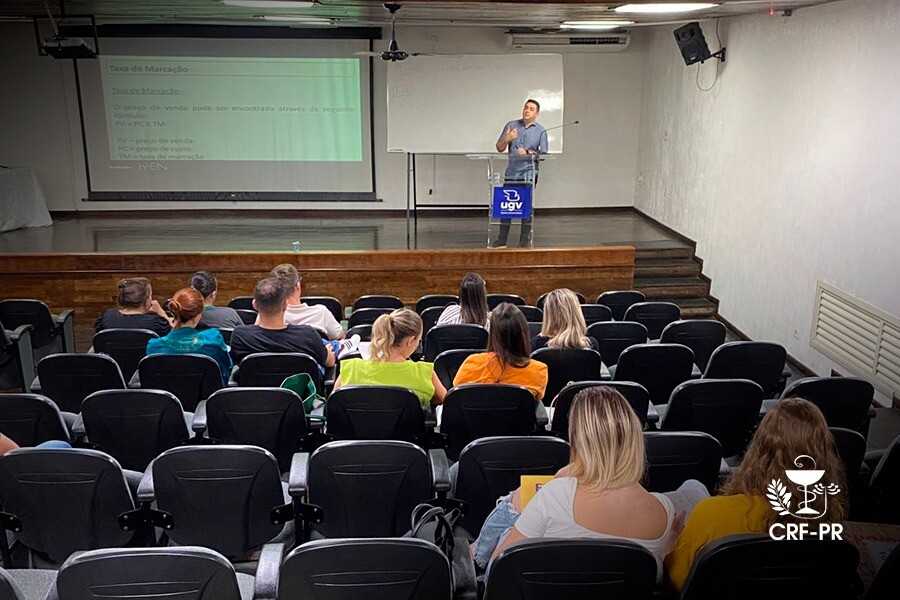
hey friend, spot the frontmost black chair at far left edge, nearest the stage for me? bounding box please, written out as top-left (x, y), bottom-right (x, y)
top-left (0, 299), bottom-right (75, 362)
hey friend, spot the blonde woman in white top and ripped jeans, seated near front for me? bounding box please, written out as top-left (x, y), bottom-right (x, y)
top-left (473, 386), bottom-right (675, 577)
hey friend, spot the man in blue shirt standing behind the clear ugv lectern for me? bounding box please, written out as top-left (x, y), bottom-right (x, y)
top-left (491, 98), bottom-right (547, 248)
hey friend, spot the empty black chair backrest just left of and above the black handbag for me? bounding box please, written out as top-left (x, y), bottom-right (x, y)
top-left (308, 441), bottom-right (433, 537)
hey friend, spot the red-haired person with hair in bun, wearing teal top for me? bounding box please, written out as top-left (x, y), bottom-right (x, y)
top-left (147, 288), bottom-right (231, 385)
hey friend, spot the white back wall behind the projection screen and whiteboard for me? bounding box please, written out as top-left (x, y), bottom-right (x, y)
top-left (0, 24), bottom-right (644, 210)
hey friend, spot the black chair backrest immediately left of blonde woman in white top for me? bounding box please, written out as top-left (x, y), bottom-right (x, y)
top-left (454, 434), bottom-right (569, 536)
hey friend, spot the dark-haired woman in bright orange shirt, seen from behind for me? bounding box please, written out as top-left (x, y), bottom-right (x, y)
top-left (453, 302), bottom-right (547, 400)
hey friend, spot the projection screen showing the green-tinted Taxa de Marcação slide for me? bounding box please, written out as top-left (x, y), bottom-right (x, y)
top-left (79, 38), bottom-right (375, 200)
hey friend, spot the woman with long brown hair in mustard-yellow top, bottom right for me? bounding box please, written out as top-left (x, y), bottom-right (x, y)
top-left (666, 398), bottom-right (846, 590)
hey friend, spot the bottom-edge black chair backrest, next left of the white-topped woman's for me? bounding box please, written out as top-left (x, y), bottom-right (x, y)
top-left (278, 538), bottom-right (451, 600)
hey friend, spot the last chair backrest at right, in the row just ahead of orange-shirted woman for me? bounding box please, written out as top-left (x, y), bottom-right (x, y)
top-left (703, 341), bottom-right (787, 398)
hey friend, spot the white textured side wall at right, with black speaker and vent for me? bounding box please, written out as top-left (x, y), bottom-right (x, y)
top-left (635, 0), bottom-right (900, 398)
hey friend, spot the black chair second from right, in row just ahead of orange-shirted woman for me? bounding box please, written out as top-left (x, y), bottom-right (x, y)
top-left (610, 344), bottom-right (694, 405)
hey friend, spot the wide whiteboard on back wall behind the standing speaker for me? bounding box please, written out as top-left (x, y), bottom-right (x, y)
top-left (387, 54), bottom-right (563, 154)
